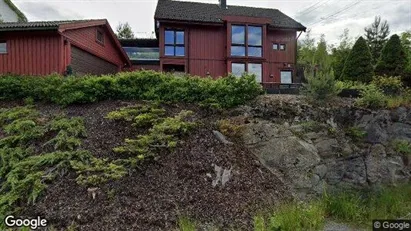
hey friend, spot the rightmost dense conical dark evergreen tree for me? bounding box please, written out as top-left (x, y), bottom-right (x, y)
top-left (375, 34), bottom-right (407, 76)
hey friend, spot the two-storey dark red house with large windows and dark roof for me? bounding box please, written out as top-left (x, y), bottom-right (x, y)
top-left (122, 0), bottom-right (306, 84)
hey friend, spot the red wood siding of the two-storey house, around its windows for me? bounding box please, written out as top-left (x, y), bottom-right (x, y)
top-left (159, 17), bottom-right (296, 82)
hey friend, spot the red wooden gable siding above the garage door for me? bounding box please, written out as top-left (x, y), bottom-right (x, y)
top-left (63, 26), bottom-right (125, 70)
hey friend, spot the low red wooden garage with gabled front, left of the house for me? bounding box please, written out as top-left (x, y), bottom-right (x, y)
top-left (0, 19), bottom-right (131, 75)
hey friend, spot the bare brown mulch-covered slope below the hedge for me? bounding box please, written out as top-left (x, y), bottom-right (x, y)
top-left (12, 101), bottom-right (288, 230)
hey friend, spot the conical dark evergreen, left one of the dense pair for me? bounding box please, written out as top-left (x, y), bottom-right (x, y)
top-left (342, 37), bottom-right (374, 82)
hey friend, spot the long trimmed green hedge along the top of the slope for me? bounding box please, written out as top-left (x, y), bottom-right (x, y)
top-left (0, 71), bottom-right (263, 108)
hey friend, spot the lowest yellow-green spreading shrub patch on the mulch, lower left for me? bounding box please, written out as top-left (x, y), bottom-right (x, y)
top-left (70, 157), bottom-right (127, 186)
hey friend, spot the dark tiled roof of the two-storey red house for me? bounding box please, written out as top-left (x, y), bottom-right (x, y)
top-left (154, 0), bottom-right (306, 31)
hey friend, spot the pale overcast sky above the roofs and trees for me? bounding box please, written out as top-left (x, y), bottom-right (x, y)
top-left (13, 0), bottom-right (411, 43)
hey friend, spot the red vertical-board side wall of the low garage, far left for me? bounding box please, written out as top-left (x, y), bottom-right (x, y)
top-left (0, 32), bottom-right (64, 75)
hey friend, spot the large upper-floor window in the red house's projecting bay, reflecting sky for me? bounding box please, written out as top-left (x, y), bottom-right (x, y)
top-left (231, 25), bottom-right (263, 57)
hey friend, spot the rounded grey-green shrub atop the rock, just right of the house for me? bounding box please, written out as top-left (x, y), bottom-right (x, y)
top-left (301, 67), bottom-right (341, 103)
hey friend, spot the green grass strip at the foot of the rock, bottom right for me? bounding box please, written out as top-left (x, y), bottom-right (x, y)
top-left (254, 185), bottom-right (411, 231)
